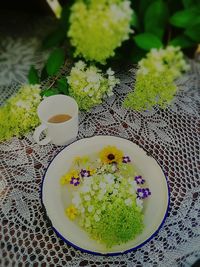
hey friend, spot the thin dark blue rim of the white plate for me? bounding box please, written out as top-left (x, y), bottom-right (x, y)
top-left (40, 135), bottom-right (170, 256)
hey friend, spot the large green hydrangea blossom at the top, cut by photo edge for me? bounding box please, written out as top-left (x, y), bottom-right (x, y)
top-left (68, 0), bottom-right (132, 64)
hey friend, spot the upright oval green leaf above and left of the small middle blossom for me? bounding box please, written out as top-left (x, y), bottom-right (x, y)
top-left (46, 48), bottom-right (65, 76)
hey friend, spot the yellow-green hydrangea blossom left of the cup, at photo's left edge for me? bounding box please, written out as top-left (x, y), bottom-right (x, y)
top-left (0, 85), bottom-right (41, 141)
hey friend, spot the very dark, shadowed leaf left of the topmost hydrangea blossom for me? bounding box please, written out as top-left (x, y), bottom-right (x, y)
top-left (42, 27), bottom-right (67, 49)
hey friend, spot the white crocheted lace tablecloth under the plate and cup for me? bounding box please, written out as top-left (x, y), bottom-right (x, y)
top-left (0, 36), bottom-right (200, 267)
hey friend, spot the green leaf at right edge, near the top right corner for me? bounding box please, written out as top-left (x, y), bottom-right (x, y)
top-left (170, 8), bottom-right (199, 28)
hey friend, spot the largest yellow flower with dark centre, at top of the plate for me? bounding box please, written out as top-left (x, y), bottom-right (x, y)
top-left (100, 146), bottom-right (123, 163)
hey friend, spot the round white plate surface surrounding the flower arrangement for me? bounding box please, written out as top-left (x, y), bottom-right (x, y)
top-left (41, 136), bottom-right (169, 255)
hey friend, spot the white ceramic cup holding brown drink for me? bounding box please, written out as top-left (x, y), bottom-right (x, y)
top-left (33, 95), bottom-right (78, 145)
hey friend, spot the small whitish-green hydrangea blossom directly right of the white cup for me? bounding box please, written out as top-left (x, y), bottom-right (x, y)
top-left (68, 61), bottom-right (119, 111)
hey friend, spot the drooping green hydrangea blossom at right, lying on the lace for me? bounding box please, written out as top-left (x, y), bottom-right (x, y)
top-left (123, 46), bottom-right (189, 111)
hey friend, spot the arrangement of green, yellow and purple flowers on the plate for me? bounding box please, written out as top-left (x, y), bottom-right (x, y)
top-left (60, 146), bottom-right (151, 247)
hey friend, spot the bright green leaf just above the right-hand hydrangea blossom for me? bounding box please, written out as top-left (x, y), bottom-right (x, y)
top-left (134, 33), bottom-right (162, 51)
